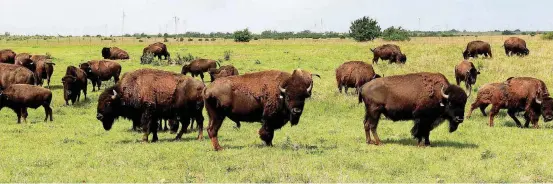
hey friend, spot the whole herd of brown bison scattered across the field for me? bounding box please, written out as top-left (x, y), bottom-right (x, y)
top-left (0, 37), bottom-right (553, 150)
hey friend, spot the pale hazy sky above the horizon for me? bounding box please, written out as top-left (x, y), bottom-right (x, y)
top-left (0, 0), bottom-right (553, 35)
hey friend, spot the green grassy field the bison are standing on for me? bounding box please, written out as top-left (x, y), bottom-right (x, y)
top-left (0, 36), bottom-right (553, 182)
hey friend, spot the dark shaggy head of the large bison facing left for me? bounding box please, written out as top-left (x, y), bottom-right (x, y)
top-left (96, 87), bottom-right (121, 130)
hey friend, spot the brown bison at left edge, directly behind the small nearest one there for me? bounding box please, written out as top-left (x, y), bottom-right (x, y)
top-left (0, 63), bottom-right (36, 89)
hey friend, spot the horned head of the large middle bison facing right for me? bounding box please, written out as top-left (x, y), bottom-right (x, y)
top-left (279, 69), bottom-right (320, 126)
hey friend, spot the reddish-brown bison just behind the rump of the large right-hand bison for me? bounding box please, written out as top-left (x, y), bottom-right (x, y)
top-left (336, 61), bottom-right (380, 94)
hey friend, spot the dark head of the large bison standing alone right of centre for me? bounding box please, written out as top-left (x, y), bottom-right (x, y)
top-left (440, 85), bottom-right (467, 132)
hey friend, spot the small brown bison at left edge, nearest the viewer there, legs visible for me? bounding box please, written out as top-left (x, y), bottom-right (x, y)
top-left (0, 84), bottom-right (53, 123)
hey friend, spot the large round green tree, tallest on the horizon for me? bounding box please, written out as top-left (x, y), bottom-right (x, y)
top-left (349, 16), bottom-right (380, 42)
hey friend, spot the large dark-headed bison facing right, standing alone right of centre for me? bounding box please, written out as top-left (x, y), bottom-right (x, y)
top-left (359, 73), bottom-right (467, 146)
